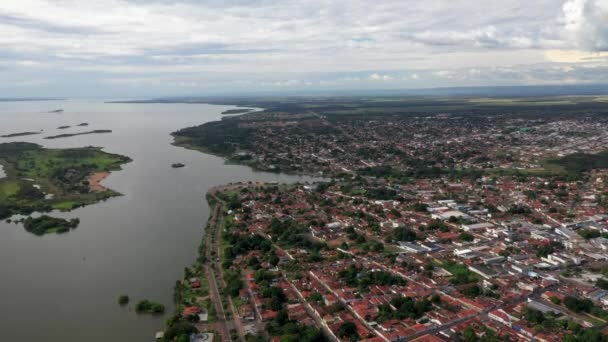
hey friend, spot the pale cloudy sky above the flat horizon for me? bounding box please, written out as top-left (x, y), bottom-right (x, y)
top-left (0, 0), bottom-right (608, 97)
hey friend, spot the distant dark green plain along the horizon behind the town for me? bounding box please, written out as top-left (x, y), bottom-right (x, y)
top-left (120, 95), bottom-right (608, 119)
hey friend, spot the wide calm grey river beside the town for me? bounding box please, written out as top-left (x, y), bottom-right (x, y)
top-left (0, 101), bottom-right (320, 342)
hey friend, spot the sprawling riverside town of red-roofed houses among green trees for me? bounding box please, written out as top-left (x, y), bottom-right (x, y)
top-left (163, 105), bottom-right (608, 342)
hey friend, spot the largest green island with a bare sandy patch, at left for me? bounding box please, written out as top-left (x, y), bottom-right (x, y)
top-left (0, 142), bottom-right (131, 224)
